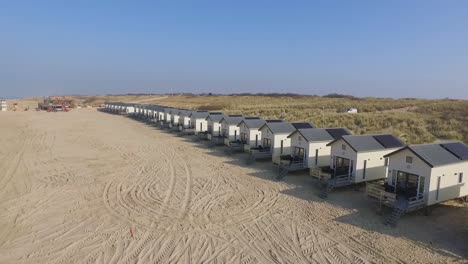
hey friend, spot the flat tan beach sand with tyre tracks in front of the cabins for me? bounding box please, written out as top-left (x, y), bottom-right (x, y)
top-left (0, 109), bottom-right (468, 263)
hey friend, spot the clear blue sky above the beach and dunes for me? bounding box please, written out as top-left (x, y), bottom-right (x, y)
top-left (0, 0), bottom-right (468, 99)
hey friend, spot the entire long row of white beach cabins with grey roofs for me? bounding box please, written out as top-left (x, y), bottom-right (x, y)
top-left (105, 102), bottom-right (468, 225)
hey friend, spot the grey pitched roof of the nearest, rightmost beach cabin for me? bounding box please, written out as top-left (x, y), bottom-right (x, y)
top-left (386, 143), bottom-right (468, 167)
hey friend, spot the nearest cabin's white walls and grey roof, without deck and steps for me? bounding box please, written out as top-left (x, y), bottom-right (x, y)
top-left (386, 142), bottom-right (468, 206)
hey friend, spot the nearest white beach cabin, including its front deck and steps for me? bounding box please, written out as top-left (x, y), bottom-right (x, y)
top-left (367, 142), bottom-right (468, 225)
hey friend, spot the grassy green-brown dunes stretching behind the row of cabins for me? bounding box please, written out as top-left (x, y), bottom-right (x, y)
top-left (94, 95), bottom-right (468, 144)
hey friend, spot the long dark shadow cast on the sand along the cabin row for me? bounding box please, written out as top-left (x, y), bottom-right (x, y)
top-left (115, 113), bottom-right (468, 258)
